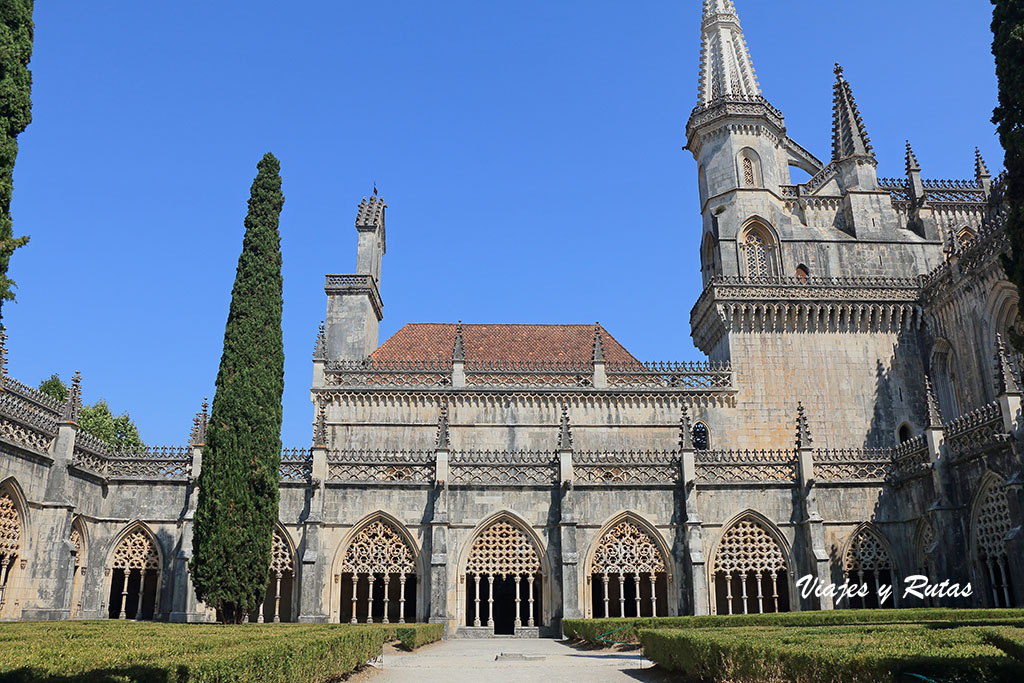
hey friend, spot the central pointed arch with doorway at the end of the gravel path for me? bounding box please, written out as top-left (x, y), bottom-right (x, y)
top-left (459, 510), bottom-right (551, 635)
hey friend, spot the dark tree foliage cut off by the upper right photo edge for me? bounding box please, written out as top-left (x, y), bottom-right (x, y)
top-left (992, 0), bottom-right (1024, 350)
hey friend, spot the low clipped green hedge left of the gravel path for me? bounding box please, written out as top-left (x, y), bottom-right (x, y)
top-left (0, 621), bottom-right (436, 683)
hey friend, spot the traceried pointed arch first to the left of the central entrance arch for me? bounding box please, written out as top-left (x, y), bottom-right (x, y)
top-left (332, 510), bottom-right (425, 624)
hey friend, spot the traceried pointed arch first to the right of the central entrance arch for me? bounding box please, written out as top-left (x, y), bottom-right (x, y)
top-left (584, 510), bottom-right (675, 617)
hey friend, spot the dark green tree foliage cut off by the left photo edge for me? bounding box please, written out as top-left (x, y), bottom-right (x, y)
top-left (0, 0), bottom-right (34, 315)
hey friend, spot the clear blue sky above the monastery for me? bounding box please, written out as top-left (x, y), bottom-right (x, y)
top-left (4, 0), bottom-right (1002, 445)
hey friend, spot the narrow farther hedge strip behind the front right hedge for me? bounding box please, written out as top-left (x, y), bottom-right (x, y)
top-left (562, 607), bottom-right (1024, 646)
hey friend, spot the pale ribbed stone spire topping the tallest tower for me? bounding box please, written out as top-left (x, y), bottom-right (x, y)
top-left (697, 0), bottom-right (761, 106)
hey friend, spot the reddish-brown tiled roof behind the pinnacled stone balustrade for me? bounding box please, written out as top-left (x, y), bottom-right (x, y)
top-left (370, 323), bottom-right (636, 362)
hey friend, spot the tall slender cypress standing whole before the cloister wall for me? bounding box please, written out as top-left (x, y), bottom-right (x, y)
top-left (190, 154), bottom-right (285, 623)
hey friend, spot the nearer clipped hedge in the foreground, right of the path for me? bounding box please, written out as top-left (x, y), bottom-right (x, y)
top-left (640, 625), bottom-right (1024, 683)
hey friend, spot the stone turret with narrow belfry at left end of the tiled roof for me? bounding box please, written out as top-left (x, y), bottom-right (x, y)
top-left (324, 190), bottom-right (387, 360)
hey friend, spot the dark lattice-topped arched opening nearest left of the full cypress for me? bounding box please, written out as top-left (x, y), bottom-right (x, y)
top-left (106, 526), bottom-right (160, 621)
